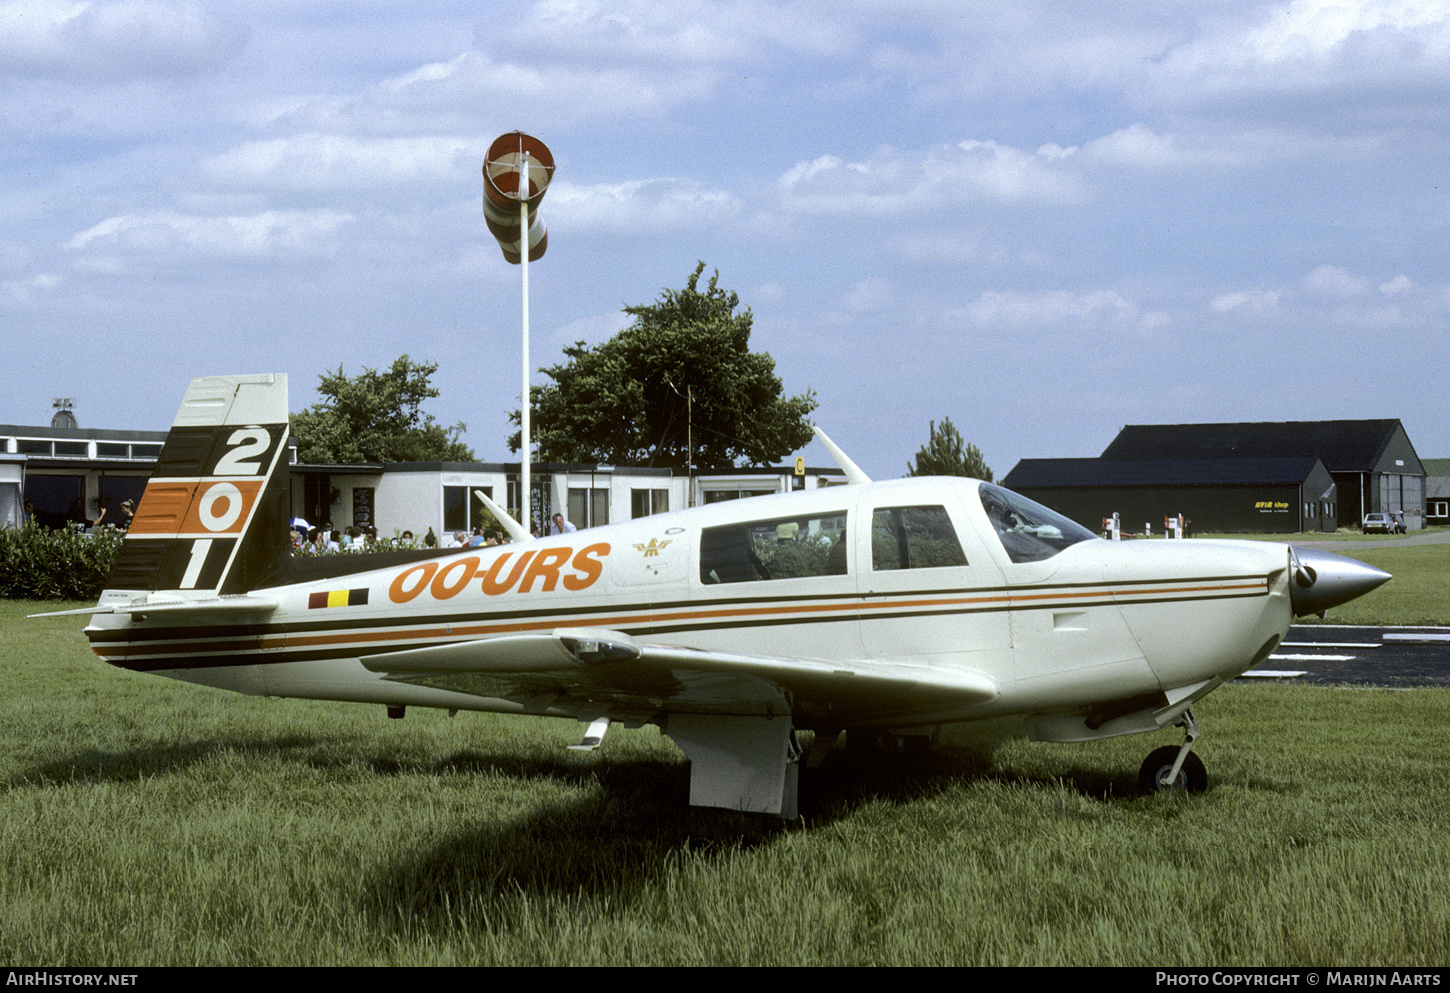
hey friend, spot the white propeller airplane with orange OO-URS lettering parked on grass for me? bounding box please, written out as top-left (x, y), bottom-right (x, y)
top-left (65, 375), bottom-right (1389, 818)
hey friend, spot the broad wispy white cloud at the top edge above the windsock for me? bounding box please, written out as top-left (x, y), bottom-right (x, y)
top-left (277, 0), bottom-right (857, 133)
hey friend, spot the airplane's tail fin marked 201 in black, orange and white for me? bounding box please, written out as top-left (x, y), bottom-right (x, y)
top-left (106, 373), bottom-right (289, 594)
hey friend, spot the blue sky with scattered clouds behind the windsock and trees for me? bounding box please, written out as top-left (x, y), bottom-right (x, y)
top-left (0, 0), bottom-right (1450, 478)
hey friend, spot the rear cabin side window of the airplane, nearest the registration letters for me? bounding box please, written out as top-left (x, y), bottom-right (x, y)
top-left (700, 510), bottom-right (847, 584)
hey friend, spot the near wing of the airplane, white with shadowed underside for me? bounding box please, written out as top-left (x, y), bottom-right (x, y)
top-left (363, 628), bottom-right (998, 726)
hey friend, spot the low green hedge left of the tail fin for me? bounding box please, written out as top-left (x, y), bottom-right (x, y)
top-left (0, 525), bottom-right (125, 600)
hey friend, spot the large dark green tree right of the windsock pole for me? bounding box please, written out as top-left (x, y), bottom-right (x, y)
top-left (509, 262), bottom-right (816, 468)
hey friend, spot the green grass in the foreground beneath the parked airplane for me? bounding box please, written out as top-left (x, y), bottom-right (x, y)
top-left (0, 602), bottom-right (1450, 965)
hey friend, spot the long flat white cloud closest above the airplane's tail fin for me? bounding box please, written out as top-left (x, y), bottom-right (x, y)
top-left (65, 210), bottom-right (352, 259)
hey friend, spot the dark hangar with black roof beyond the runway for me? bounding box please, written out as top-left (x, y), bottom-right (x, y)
top-left (1002, 420), bottom-right (1425, 532)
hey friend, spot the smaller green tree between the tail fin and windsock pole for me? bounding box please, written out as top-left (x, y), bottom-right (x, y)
top-left (291, 355), bottom-right (474, 462)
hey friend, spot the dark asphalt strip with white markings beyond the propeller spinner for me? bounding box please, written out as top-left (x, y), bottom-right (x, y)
top-left (1241, 623), bottom-right (1450, 689)
